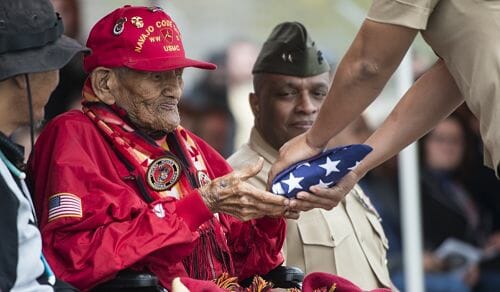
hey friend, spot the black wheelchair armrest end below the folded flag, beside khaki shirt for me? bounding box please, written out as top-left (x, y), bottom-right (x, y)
top-left (240, 266), bottom-right (304, 289)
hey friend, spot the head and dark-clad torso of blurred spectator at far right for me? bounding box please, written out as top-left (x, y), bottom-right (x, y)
top-left (421, 115), bottom-right (485, 253)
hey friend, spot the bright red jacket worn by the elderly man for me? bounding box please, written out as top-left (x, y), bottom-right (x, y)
top-left (28, 110), bottom-right (285, 290)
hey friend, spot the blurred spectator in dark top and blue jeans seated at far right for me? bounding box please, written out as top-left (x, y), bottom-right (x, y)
top-left (396, 114), bottom-right (500, 291)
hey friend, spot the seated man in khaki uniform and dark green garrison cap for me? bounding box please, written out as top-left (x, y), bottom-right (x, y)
top-left (228, 22), bottom-right (392, 289)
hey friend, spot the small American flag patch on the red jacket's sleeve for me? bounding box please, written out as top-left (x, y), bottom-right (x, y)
top-left (49, 193), bottom-right (82, 222)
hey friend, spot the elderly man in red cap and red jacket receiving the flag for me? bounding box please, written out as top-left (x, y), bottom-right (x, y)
top-left (29, 5), bottom-right (288, 290)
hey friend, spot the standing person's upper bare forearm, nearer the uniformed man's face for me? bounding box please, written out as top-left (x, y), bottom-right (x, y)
top-left (307, 20), bottom-right (417, 147)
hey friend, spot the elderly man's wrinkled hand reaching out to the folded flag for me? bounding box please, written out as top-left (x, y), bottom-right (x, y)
top-left (200, 157), bottom-right (289, 221)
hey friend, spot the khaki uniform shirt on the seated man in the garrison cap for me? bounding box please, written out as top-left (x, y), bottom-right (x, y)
top-left (228, 129), bottom-right (393, 290)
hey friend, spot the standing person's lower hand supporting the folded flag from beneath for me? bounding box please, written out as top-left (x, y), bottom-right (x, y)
top-left (285, 170), bottom-right (361, 219)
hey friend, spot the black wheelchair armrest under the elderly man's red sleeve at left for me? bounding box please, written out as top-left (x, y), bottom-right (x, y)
top-left (92, 270), bottom-right (159, 292)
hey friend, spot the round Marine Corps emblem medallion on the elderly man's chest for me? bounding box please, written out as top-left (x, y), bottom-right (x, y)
top-left (146, 156), bottom-right (181, 192)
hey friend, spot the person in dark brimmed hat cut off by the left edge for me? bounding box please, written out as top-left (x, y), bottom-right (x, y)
top-left (0, 0), bottom-right (86, 291)
